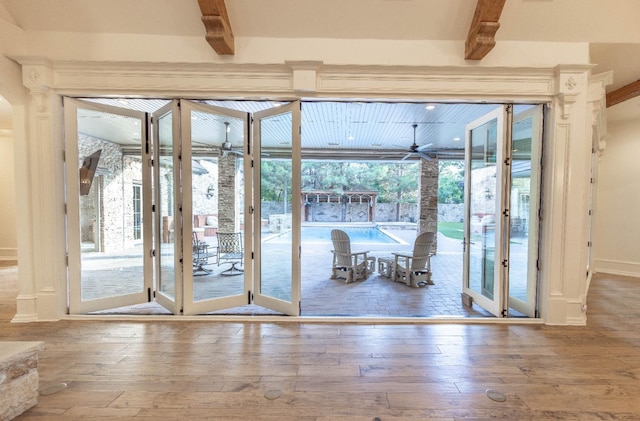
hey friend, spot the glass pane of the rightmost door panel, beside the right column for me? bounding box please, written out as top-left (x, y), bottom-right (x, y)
top-left (509, 118), bottom-right (537, 301)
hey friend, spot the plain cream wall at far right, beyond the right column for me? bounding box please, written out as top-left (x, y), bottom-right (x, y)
top-left (594, 120), bottom-right (640, 276)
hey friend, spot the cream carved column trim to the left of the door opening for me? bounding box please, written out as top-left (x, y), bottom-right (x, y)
top-left (13, 59), bottom-right (66, 322)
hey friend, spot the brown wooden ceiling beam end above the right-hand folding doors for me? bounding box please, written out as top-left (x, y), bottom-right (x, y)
top-left (464, 0), bottom-right (507, 60)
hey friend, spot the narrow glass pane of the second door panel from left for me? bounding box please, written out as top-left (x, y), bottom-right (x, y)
top-left (156, 113), bottom-right (180, 299)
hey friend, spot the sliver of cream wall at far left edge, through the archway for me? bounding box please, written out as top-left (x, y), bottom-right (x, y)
top-left (0, 128), bottom-right (17, 260)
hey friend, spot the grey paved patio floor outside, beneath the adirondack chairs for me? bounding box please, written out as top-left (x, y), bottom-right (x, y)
top-left (93, 229), bottom-right (492, 317)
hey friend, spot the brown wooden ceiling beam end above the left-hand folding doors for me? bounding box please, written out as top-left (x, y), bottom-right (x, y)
top-left (198, 0), bottom-right (235, 55)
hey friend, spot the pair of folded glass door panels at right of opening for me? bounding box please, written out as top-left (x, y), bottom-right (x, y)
top-left (463, 106), bottom-right (542, 317)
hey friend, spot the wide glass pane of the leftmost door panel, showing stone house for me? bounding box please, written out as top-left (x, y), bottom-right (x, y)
top-left (77, 109), bottom-right (144, 301)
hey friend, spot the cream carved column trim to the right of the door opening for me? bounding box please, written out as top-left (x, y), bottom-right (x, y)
top-left (540, 66), bottom-right (592, 325)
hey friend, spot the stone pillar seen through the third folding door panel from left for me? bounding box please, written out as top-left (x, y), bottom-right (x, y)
top-left (218, 153), bottom-right (240, 232)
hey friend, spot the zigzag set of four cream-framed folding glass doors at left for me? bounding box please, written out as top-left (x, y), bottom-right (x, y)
top-left (65, 98), bottom-right (300, 315)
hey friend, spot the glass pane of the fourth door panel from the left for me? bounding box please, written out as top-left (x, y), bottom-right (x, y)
top-left (256, 112), bottom-right (300, 302)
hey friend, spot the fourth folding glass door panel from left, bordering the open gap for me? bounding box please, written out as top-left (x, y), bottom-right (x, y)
top-left (253, 101), bottom-right (301, 315)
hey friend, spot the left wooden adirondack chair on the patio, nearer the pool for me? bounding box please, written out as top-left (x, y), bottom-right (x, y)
top-left (331, 230), bottom-right (376, 283)
